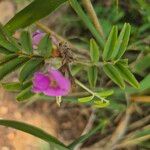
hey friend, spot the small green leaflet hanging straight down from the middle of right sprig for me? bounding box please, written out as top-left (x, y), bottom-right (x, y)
top-left (88, 66), bottom-right (98, 87)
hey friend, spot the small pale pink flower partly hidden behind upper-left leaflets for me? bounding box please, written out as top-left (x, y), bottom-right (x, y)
top-left (32, 30), bottom-right (45, 46)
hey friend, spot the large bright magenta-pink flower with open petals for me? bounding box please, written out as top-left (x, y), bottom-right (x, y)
top-left (32, 69), bottom-right (71, 96)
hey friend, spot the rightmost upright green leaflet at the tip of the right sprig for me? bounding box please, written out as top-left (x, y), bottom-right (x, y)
top-left (111, 23), bottom-right (131, 60)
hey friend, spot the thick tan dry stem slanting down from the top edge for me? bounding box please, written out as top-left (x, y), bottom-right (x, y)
top-left (82, 0), bottom-right (105, 38)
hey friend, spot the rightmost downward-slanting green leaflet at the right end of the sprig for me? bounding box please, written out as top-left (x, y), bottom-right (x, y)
top-left (115, 62), bottom-right (139, 88)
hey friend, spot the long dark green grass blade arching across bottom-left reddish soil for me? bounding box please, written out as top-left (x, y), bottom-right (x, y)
top-left (0, 119), bottom-right (69, 150)
